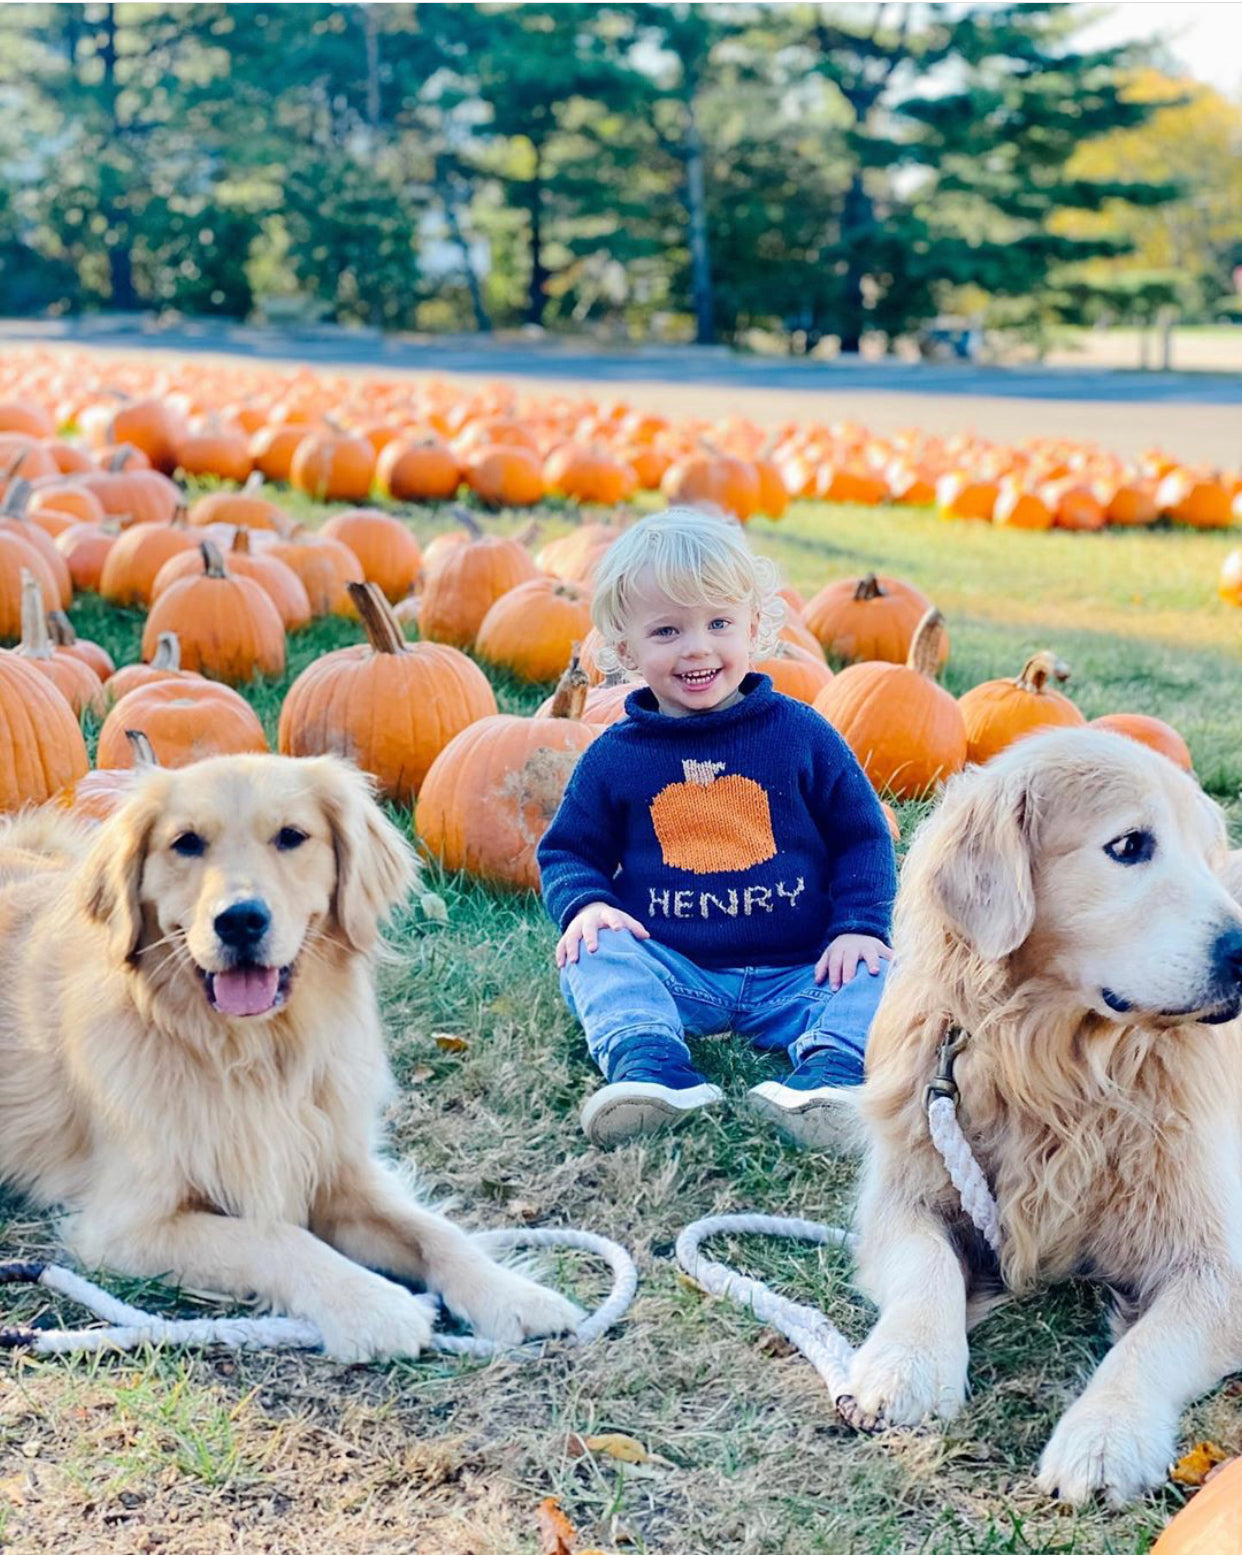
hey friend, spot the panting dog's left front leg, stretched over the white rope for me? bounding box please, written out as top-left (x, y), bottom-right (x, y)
top-left (67, 1208), bottom-right (435, 1361)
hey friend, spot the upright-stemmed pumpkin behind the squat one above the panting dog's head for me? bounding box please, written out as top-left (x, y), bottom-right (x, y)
top-left (143, 540), bottom-right (284, 686)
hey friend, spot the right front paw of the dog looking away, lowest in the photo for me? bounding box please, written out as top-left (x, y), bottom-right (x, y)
top-left (1038, 1395), bottom-right (1174, 1507)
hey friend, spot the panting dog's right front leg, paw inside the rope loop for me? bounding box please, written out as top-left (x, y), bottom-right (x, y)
top-left (311, 1160), bottom-right (581, 1344)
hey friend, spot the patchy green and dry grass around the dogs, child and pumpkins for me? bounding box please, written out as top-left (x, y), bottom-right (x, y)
top-left (0, 504), bottom-right (1242, 1555)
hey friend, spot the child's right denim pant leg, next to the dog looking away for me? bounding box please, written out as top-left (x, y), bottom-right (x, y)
top-left (737, 961), bottom-right (888, 1085)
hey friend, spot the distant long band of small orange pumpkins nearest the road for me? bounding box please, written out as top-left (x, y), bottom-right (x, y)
top-left (0, 353), bottom-right (1242, 530)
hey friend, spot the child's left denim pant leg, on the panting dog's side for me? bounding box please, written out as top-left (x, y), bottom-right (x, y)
top-left (561, 928), bottom-right (735, 1078)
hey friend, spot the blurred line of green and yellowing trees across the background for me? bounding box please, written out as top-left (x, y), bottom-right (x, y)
top-left (0, 3), bottom-right (1242, 351)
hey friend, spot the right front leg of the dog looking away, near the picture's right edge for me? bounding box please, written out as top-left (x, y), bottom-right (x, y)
top-left (1038, 1270), bottom-right (1242, 1507)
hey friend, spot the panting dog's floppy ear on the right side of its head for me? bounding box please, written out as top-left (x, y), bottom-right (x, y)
top-left (308, 756), bottom-right (418, 950)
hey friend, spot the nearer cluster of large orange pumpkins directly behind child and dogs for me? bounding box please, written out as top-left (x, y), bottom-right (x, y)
top-left (0, 494), bottom-right (1191, 886)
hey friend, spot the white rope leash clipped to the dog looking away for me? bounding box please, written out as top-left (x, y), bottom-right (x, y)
top-left (676, 1095), bottom-right (1001, 1427)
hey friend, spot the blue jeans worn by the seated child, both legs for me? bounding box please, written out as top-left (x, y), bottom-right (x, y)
top-left (561, 928), bottom-right (888, 1085)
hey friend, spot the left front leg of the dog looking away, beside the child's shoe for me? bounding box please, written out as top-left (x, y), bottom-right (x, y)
top-left (849, 1152), bottom-right (970, 1426)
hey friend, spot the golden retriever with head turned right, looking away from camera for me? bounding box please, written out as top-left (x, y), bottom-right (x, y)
top-left (849, 729), bottom-right (1242, 1504)
